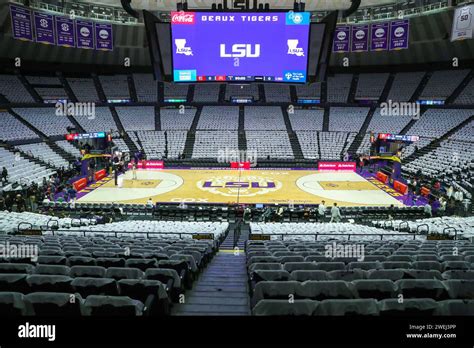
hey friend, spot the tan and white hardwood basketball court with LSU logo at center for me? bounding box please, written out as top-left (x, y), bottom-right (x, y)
top-left (78, 169), bottom-right (403, 207)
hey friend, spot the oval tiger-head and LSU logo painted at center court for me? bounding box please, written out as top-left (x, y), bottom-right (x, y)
top-left (196, 175), bottom-right (283, 197)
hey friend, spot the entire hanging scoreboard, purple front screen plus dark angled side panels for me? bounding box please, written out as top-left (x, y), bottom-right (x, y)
top-left (143, 11), bottom-right (337, 84)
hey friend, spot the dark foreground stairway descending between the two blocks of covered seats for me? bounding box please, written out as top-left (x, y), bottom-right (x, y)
top-left (171, 250), bottom-right (250, 316)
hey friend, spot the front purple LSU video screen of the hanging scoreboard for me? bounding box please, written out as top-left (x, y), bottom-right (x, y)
top-left (171, 12), bottom-right (310, 83)
